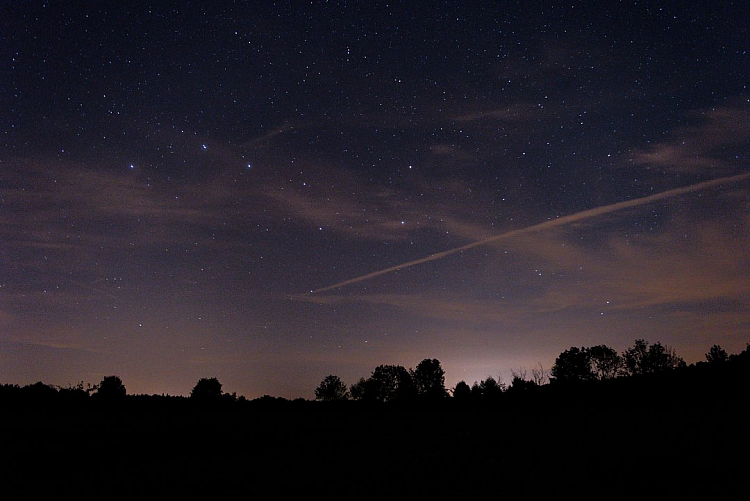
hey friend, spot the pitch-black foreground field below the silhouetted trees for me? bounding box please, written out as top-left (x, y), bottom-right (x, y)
top-left (0, 366), bottom-right (750, 499)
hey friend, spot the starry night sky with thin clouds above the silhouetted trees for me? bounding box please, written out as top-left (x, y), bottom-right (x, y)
top-left (0, 1), bottom-right (750, 398)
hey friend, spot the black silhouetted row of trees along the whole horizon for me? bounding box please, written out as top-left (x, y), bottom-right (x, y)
top-left (0, 339), bottom-right (750, 409)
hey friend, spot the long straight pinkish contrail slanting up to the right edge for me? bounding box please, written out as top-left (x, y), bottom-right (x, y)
top-left (311, 173), bottom-right (750, 294)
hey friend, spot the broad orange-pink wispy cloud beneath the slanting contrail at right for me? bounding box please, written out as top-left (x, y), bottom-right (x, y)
top-left (293, 177), bottom-right (750, 349)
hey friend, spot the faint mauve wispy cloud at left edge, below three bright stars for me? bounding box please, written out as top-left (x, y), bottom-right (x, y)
top-left (0, 155), bottom-right (250, 251)
